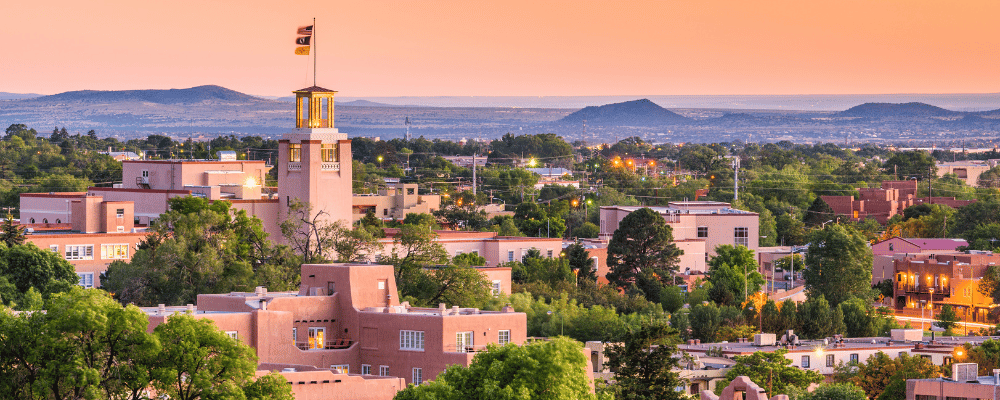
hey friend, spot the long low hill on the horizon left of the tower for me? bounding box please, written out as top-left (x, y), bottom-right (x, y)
top-left (31, 85), bottom-right (274, 104)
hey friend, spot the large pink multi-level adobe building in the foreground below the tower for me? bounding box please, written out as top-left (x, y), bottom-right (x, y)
top-left (144, 264), bottom-right (527, 400)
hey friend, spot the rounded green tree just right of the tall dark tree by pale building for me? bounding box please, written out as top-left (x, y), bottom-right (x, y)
top-left (708, 244), bottom-right (764, 306)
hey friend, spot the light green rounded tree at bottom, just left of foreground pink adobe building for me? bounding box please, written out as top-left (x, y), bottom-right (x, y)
top-left (152, 314), bottom-right (257, 400)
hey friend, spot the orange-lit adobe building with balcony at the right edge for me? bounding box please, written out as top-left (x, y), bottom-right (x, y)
top-left (893, 251), bottom-right (1000, 322)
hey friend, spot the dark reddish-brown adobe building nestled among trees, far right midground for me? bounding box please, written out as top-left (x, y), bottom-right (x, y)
top-left (820, 180), bottom-right (976, 224)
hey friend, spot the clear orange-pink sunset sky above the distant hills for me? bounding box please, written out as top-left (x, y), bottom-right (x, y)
top-left (0, 0), bottom-right (1000, 97)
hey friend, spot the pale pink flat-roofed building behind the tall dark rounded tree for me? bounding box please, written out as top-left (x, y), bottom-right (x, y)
top-left (598, 201), bottom-right (760, 273)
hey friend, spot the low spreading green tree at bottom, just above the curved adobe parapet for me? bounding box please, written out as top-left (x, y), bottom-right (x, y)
top-left (715, 349), bottom-right (823, 396)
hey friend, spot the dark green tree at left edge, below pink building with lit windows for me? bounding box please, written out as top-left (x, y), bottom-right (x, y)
top-left (0, 243), bottom-right (80, 309)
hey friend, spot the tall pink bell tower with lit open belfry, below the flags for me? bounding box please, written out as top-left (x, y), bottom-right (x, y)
top-left (278, 86), bottom-right (353, 225)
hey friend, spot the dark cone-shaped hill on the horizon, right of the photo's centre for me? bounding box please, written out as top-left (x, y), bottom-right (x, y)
top-left (558, 99), bottom-right (690, 126)
